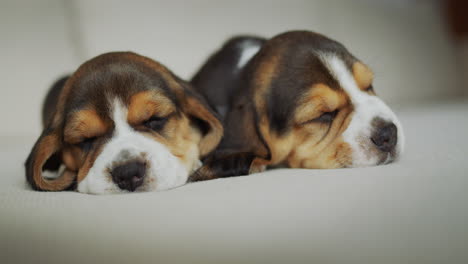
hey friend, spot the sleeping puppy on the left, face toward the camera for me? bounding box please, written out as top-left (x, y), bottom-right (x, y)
top-left (25, 52), bottom-right (223, 194)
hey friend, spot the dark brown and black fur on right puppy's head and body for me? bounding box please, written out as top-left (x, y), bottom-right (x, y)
top-left (191, 31), bottom-right (357, 181)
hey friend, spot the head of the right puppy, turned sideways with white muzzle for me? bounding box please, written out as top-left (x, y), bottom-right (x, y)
top-left (245, 31), bottom-right (404, 168)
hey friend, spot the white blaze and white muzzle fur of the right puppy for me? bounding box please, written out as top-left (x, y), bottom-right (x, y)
top-left (319, 54), bottom-right (404, 167)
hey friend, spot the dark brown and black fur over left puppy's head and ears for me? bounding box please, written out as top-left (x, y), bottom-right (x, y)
top-left (25, 52), bottom-right (223, 191)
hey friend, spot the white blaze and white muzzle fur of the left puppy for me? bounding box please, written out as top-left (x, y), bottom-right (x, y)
top-left (78, 99), bottom-right (189, 194)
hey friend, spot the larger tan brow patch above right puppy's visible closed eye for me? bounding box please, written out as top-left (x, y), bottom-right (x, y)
top-left (295, 83), bottom-right (346, 124)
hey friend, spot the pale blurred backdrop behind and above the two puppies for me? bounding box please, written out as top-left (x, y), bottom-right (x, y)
top-left (0, 0), bottom-right (468, 136)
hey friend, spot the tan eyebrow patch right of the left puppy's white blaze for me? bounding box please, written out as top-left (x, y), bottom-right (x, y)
top-left (127, 90), bottom-right (176, 125)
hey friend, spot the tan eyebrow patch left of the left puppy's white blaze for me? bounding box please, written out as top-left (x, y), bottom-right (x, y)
top-left (64, 109), bottom-right (109, 144)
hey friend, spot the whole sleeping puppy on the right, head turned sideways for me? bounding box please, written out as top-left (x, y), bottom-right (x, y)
top-left (191, 31), bottom-right (404, 181)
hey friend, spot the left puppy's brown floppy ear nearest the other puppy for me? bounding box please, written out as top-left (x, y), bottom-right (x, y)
top-left (178, 81), bottom-right (224, 157)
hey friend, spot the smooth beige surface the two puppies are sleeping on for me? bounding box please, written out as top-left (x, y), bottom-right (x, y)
top-left (0, 102), bottom-right (468, 263)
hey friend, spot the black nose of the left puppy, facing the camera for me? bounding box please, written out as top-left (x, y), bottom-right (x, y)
top-left (111, 161), bottom-right (146, 192)
